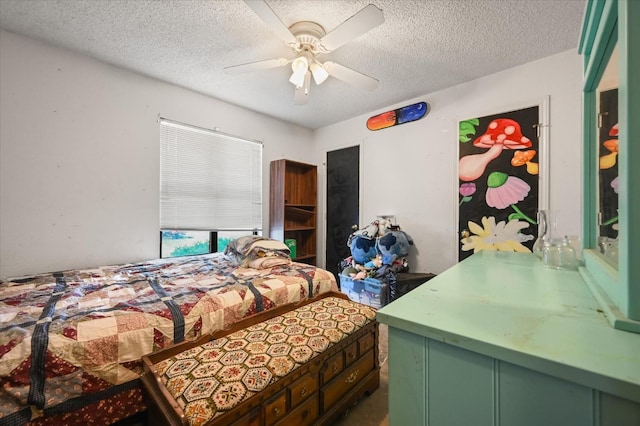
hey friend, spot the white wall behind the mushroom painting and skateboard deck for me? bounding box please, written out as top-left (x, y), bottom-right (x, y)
top-left (315, 50), bottom-right (582, 273)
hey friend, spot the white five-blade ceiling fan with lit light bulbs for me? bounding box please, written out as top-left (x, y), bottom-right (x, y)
top-left (224, 0), bottom-right (384, 105)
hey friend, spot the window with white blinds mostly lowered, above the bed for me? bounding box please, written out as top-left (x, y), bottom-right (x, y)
top-left (160, 119), bottom-right (262, 257)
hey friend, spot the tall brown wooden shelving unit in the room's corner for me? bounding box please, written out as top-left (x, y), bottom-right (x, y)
top-left (269, 159), bottom-right (318, 265)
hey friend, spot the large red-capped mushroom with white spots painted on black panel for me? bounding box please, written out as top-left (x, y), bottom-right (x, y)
top-left (458, 118), bottom-right (531, 182)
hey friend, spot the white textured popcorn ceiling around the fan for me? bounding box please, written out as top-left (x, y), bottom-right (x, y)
top-left (0, 0), bottom-right (585, 129)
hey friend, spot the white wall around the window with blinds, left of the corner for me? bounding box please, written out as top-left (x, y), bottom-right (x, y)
top-left (0, 31), bottom-right (314, 277)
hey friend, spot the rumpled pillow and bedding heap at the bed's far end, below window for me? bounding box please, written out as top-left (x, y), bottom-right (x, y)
top-left (224, 235), bottom-right (291, 269)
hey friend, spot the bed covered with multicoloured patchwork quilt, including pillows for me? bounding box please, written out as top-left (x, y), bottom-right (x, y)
top-left (0, 237), bottom-right (337, 425)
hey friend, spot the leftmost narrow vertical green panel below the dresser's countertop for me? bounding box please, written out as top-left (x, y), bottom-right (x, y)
top-left (388, 327), bottom-right (428, 426)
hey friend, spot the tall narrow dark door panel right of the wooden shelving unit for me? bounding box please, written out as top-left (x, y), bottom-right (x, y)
top-left (326, 146), bottom-right (360, 279)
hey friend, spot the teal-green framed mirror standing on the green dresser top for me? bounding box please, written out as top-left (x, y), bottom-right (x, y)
top-left (579, 0), bottom-right (640, 333)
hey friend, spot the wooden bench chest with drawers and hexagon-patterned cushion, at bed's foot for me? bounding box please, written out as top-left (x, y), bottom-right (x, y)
top-left (142, 293), bottom-right (380, 426)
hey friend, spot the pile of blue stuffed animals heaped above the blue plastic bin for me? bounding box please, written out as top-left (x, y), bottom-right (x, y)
top-left (340, 219), bottom-right (413, 281)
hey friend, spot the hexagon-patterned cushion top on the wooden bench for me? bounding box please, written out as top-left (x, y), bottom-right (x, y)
top-left (155, 297), bottom-right (375, 426)
